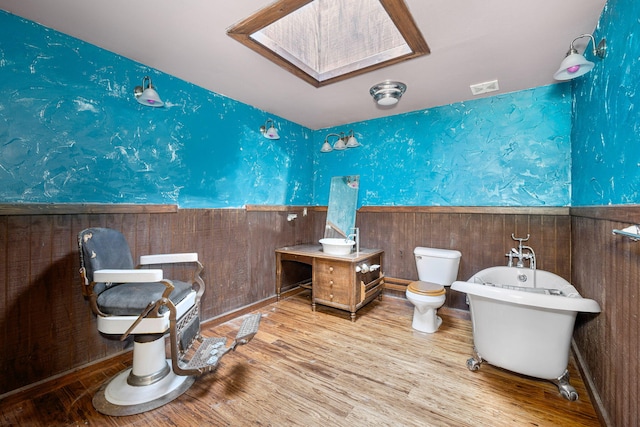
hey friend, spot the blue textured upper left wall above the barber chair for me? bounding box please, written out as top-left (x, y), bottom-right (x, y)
top-left (0, 11), bottom-right (313, 207)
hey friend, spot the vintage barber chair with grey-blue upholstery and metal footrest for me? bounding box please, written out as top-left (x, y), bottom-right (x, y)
top-left (78, 228), bottom-right (261, 416)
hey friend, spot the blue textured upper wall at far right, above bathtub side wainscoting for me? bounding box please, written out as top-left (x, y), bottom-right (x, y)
top-left (571, 0), bottom-right (640, 206)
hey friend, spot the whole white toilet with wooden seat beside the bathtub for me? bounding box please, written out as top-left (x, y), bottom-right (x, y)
top-left (407, 247), bottom-right (462, 333)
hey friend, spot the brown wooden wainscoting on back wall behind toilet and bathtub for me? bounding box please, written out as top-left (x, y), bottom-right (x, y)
top-left (357, 207), bottom-right (571, 309)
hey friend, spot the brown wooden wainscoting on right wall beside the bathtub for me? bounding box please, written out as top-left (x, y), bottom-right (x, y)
top-left (571, 211), bottom-right (640, 426)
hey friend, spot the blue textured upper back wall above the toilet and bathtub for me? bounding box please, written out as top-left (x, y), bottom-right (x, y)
top-left (315, 84), bottom-right (571, 206)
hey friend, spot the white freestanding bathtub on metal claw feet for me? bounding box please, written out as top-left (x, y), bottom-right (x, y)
top-left (451, 267), bottom-right (600, 400)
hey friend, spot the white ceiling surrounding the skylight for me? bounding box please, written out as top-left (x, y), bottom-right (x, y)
top-left (0, 0), bottom-right (606, 129)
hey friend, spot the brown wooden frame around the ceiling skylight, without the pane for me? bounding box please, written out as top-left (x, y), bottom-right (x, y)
top-left (227, 0), bottom-right (431, 87)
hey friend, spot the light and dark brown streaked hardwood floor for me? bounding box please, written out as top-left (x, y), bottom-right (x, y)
top-left (0, 291), bottom-right (600, 427)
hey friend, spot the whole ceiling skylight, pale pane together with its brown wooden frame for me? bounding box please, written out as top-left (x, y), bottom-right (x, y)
top-left (227, 0), bottom-right (430, 87)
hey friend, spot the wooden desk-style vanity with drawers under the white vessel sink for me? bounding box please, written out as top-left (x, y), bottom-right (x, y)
top-left (276, 245), bottom-right (384, 321)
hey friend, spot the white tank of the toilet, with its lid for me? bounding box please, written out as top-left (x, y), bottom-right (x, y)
top-left (413, 246), bottom-right (462, 286)
